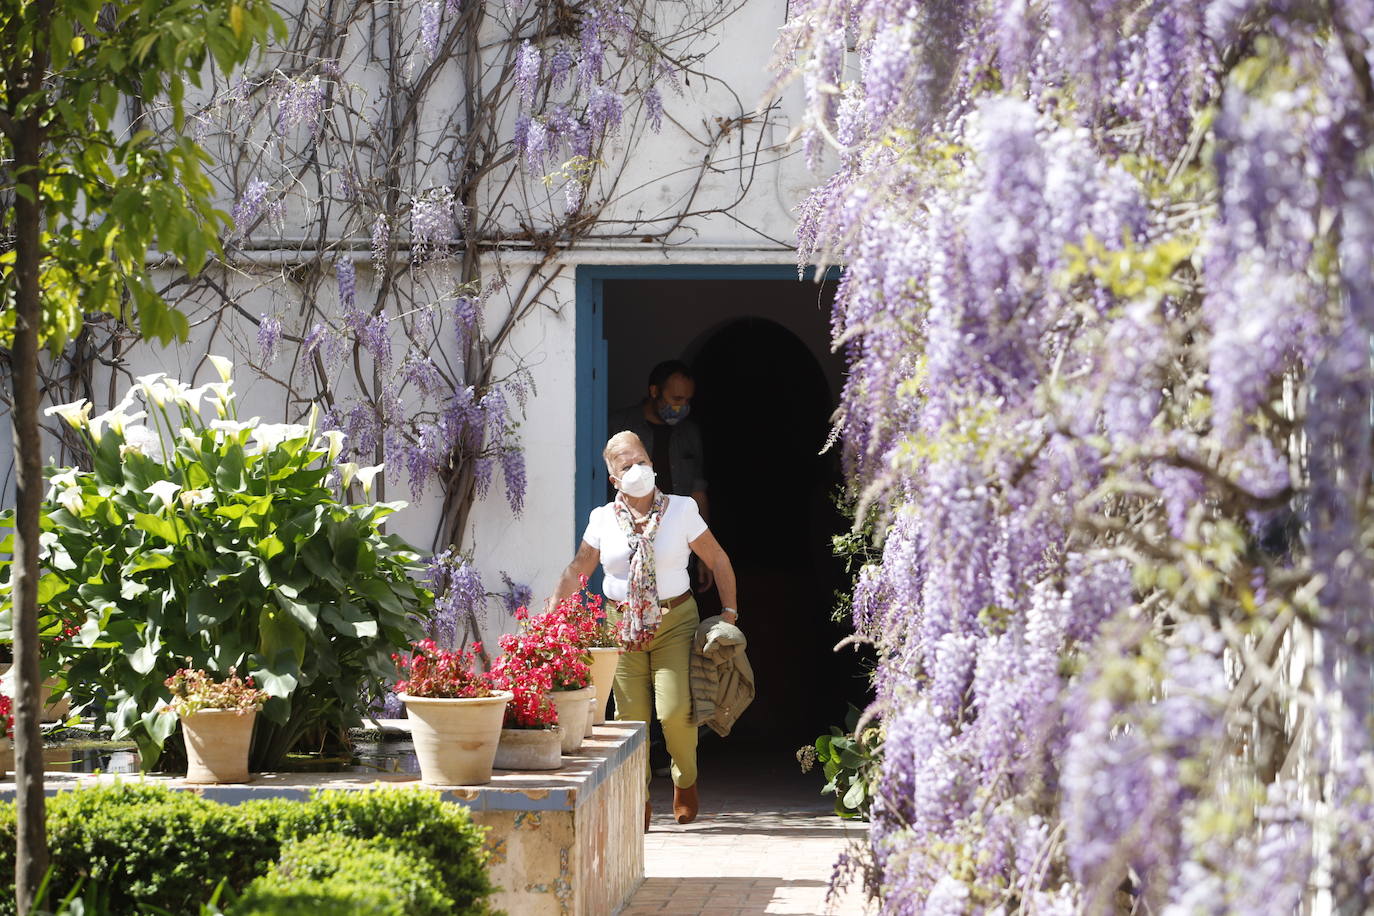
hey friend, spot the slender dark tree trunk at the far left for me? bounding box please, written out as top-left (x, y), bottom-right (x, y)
top-left (10, 103), bottom-right (48, 913)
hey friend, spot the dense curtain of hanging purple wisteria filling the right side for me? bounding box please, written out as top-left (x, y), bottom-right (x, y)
top-left (779, 0), bottom-right (1374, 916)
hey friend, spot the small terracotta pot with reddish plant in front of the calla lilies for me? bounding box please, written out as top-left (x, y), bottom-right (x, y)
top-left (164, 667), bottom-right (267, 784)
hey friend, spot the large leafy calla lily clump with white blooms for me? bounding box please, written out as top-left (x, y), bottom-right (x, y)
top-left (5, 363), bottom-right (429, 769)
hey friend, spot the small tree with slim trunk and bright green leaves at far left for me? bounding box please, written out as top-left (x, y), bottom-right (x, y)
top-left (0, 0), bottom-right (283, 912)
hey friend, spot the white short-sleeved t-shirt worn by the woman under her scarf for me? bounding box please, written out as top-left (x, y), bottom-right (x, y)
top-left (583, 496), bottom-right (706, 602)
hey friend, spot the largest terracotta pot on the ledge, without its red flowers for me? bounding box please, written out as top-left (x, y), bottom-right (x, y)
top-left (400, 691), bottom-right (513, 786)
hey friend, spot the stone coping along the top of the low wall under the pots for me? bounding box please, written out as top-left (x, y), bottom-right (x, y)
top-left (0, 722), bottom-right (649, 812)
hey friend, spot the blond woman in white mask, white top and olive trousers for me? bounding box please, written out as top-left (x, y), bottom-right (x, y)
top-left (550, 431), bottom-right (739, 829)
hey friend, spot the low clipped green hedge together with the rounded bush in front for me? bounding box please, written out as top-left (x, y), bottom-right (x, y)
top-left (0, 783), bottom-right (493, 916)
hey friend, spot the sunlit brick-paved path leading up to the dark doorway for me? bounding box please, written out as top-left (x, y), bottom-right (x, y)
top-left (621, 754), bottom-right (877, 916)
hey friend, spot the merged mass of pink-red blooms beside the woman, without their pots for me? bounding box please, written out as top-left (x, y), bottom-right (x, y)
top-left (492, 596), bottom-right (603, 728)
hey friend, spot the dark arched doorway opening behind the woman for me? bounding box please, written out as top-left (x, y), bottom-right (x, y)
top-left (603, 280), bottom-right (867, 762)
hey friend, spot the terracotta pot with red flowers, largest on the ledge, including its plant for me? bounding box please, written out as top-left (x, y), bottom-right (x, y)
top-left (396, 640), bottom-right (511, 786)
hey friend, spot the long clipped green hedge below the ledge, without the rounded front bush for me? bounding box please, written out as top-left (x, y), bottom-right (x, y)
top-left (0, 783), bottom-right (495, 916)
